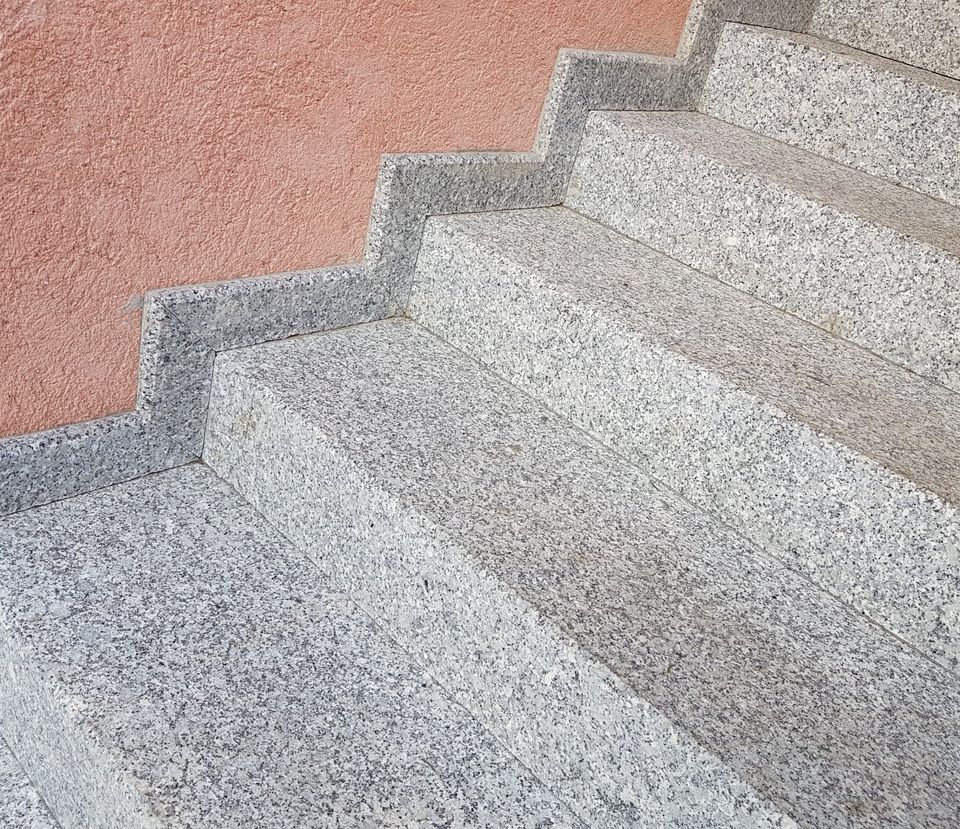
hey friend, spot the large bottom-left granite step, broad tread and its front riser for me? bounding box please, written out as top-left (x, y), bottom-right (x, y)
top-left (0, 465), bottom-right (583, 829)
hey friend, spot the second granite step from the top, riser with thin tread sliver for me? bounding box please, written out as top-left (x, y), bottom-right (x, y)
top-left (700, 25), bottom-right (960, 204)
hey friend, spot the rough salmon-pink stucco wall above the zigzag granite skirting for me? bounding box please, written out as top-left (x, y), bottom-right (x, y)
top-left (0, 0), bottom-right (688, 435)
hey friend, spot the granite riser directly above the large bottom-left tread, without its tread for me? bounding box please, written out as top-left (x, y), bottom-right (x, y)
top-left (205, 350), bottom-right (795, 827)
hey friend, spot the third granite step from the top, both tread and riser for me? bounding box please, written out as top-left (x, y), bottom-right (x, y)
top-left (565, 112), bottom-right (960, 390)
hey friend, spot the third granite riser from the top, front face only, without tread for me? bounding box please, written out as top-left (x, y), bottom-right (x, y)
top-left (565, 114), bottom-right (960, 390)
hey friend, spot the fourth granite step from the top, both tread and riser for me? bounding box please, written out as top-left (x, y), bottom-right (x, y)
top-left (410, 208), bottom-right (960, 669)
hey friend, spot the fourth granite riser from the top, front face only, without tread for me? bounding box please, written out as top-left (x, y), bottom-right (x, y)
top-left (409, 219), bottom-right (960, 668)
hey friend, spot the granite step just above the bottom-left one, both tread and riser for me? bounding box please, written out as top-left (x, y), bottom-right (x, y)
top-left (204, 321), bottom-right (960, 829)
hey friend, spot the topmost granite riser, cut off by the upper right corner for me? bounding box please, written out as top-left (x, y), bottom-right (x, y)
top-left (809, 0), bottom-right (960, 78)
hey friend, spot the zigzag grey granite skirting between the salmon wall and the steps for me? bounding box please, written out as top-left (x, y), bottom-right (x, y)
top-left (0, 0), bottom-right (816, 515)
